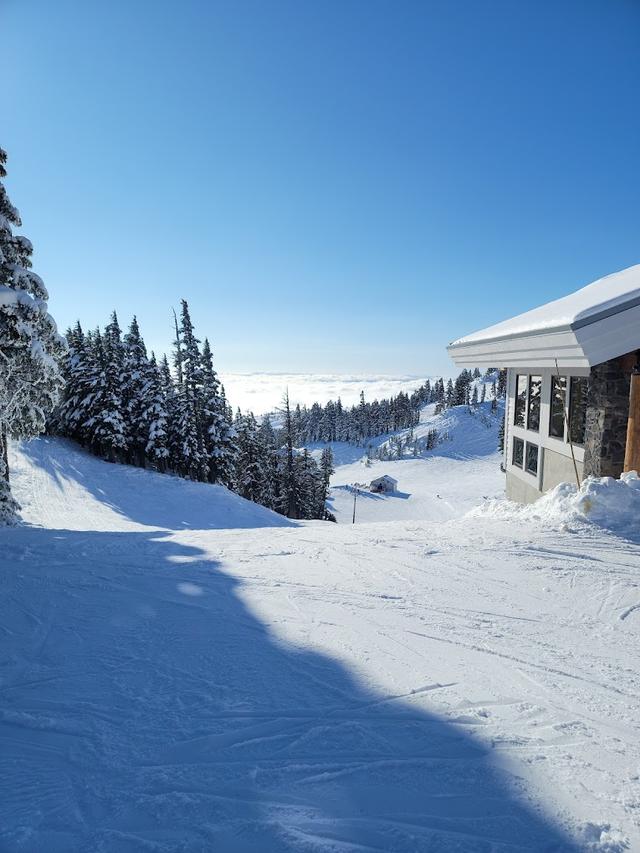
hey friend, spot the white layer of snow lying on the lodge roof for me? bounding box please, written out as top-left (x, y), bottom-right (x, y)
top-left (451, 264), bottom-right (640, 347)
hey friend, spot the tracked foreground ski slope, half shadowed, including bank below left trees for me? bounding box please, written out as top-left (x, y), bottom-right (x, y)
top-left (0, 439), bottom-right (640, 853)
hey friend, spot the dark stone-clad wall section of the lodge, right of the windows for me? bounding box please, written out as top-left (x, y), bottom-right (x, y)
top-left (584, 353), bottom-right (636, 477)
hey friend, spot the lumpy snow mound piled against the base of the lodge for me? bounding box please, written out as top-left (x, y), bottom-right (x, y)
top-left (468, 471), bottom-right (640, 536)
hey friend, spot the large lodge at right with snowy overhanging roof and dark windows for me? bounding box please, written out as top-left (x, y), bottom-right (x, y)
top-left (448, 265), bottom-right (640, 503)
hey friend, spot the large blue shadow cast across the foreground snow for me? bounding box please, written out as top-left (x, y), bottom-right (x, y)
top-left (0, 528), bottom-right (576, 853)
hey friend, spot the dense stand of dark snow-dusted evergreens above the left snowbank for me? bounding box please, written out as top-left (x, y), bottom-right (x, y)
top-left (49, 300), bottom-right (332, 518)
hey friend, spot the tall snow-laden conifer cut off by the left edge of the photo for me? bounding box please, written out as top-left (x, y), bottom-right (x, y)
top-left (0, 148), bottom-right (65, 524)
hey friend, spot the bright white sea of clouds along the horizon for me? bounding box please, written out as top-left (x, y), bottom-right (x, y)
top-left (220, 373), bottom-right (427, 415)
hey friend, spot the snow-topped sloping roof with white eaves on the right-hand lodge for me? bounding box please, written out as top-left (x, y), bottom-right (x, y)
top-left (448, 264), bottom-right (640, 367)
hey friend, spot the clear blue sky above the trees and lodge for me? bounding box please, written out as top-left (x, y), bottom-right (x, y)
top-left (0, 0), bottom-right (640, 374)
